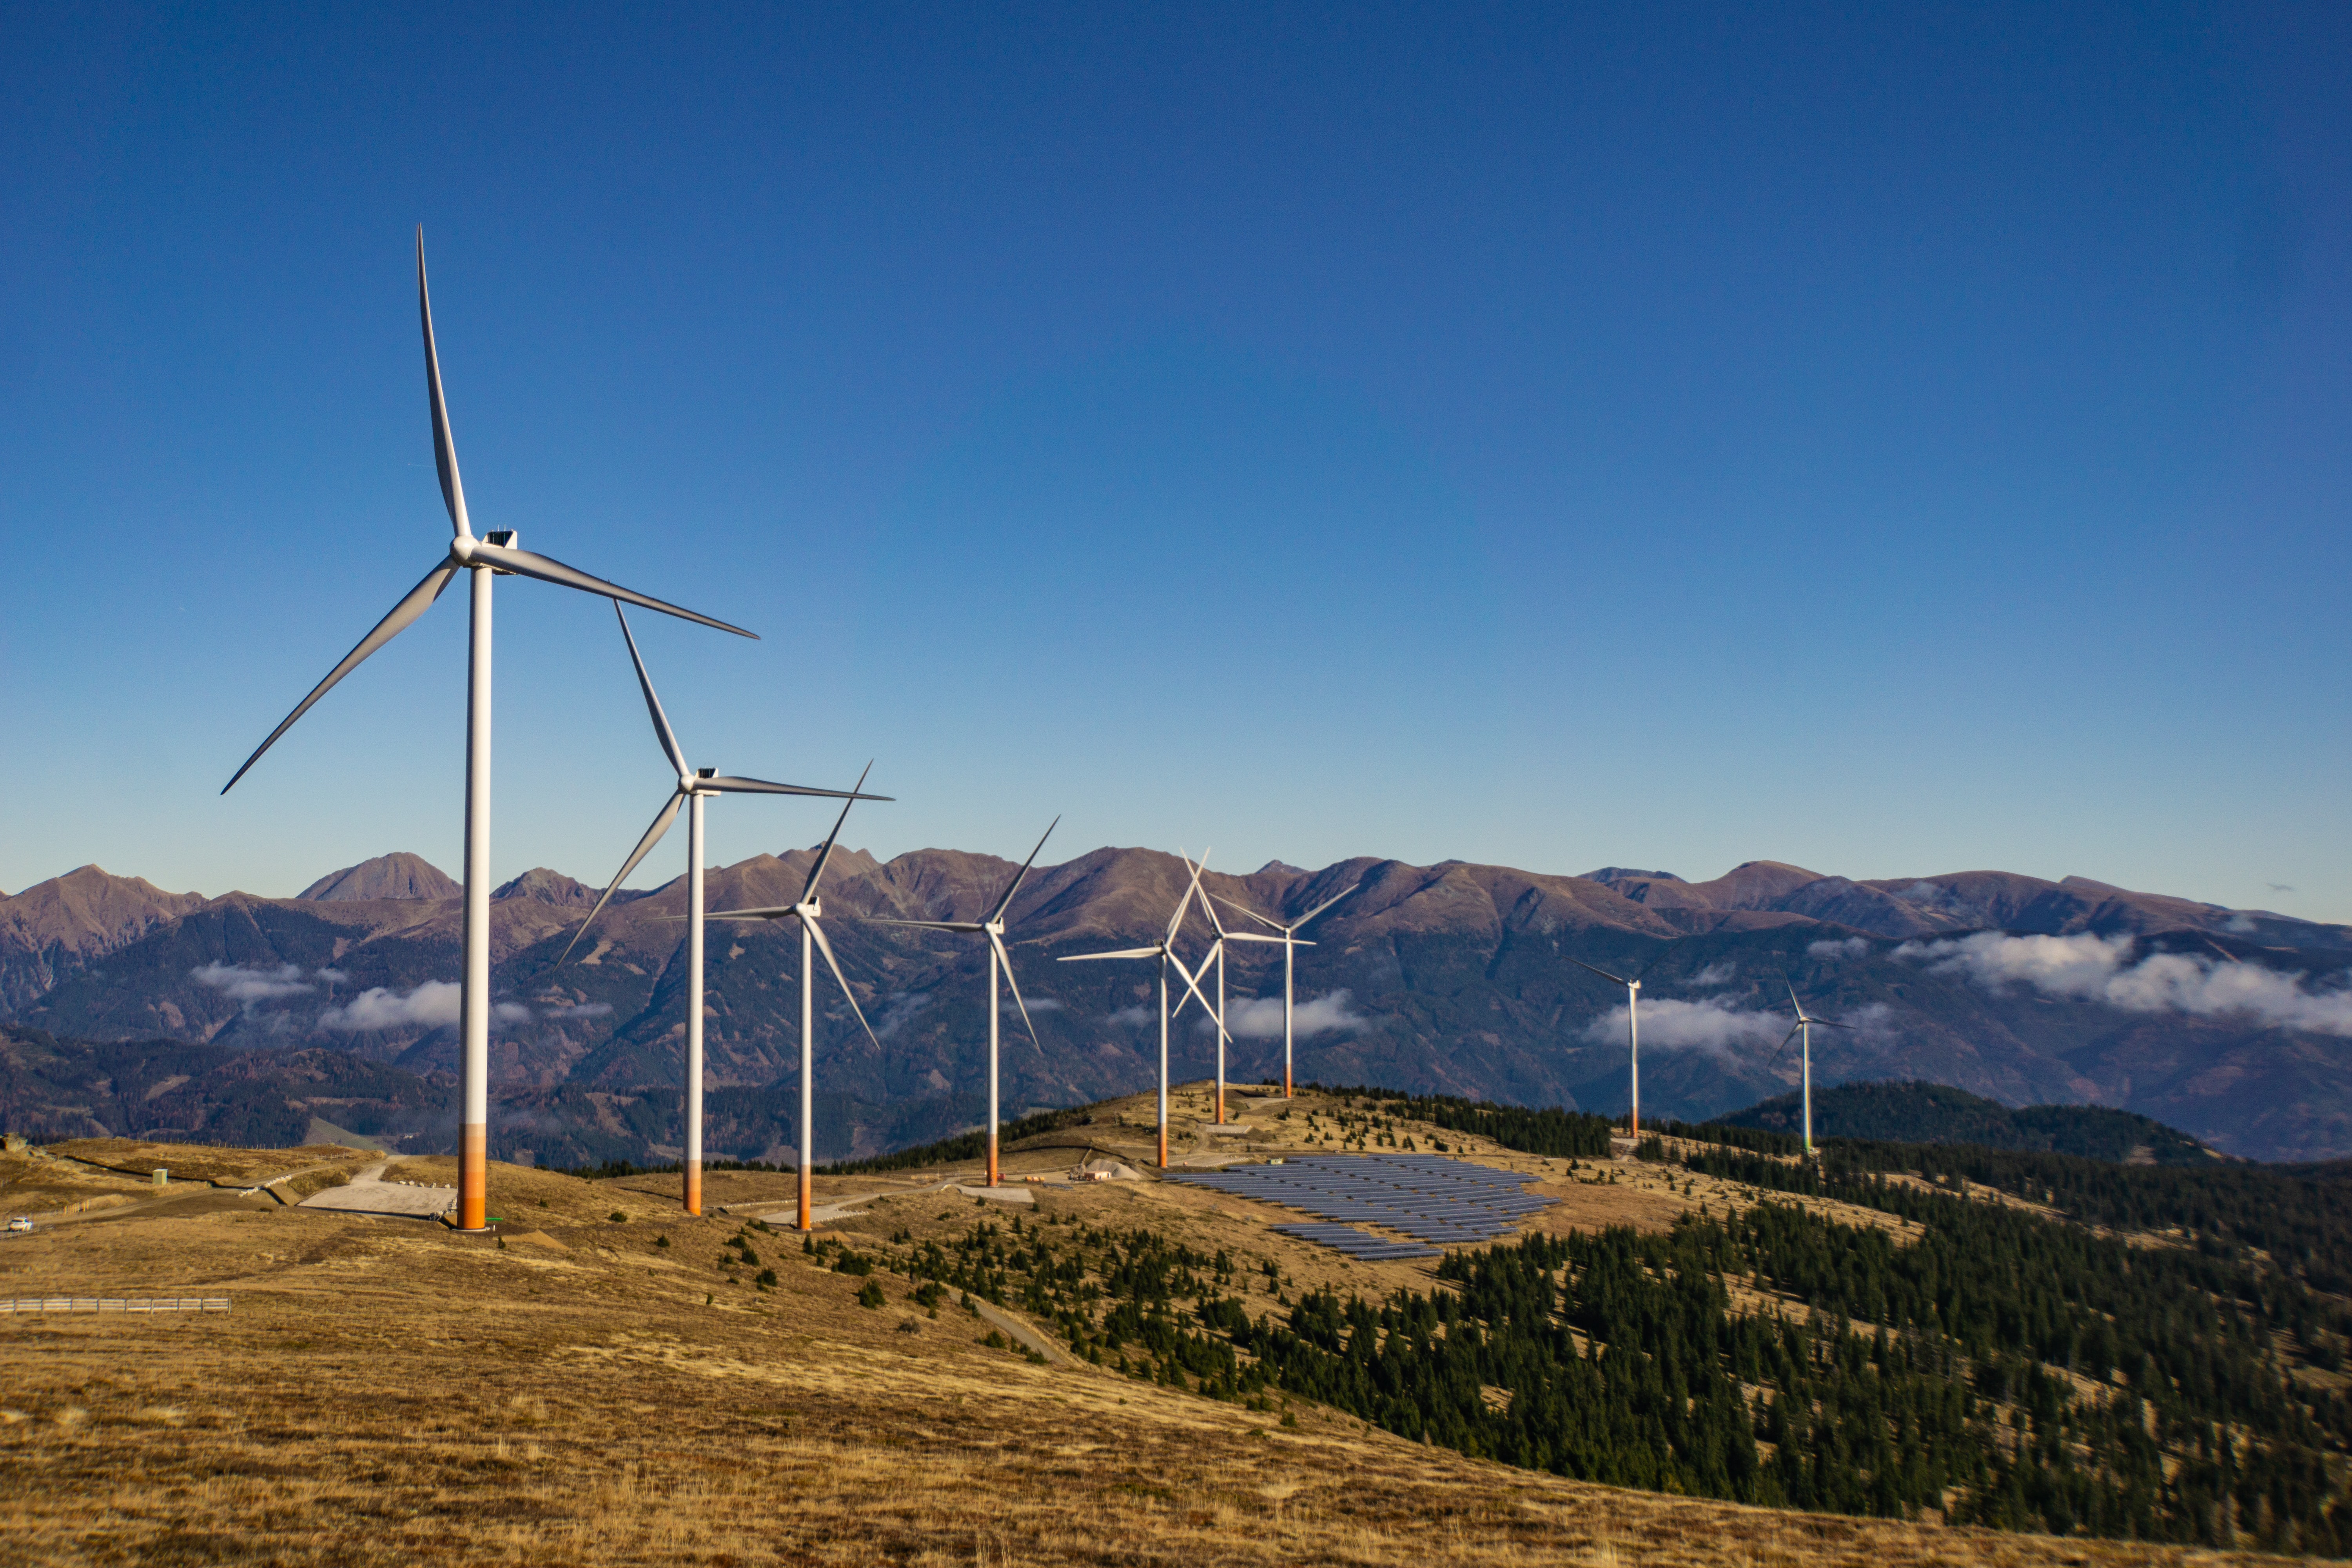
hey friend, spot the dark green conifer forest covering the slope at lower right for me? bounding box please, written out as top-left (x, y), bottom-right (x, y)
top-left (894, 1117), bottom-right (2352, 1556)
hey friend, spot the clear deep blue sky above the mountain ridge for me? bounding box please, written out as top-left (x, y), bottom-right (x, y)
top-left (0, 2), bottom-right (2352, 919)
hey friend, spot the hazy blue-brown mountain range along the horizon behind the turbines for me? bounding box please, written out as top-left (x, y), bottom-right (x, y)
top-left (0, 849), bottom-right (2352, 1159)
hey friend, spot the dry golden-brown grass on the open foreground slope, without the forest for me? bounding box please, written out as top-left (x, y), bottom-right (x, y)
top-left (0, 1142), bottom-right (2324, 1568)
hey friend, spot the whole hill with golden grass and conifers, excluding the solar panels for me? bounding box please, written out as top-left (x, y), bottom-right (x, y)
top-left (0, 1086), bottom-right (2352, 1563)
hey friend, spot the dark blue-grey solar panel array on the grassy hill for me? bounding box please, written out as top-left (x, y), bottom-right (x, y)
top-left (1167, 1154), bottom-right (1552, 1258)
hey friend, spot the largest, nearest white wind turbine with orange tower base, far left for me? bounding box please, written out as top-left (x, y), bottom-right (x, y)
top-left (221, 228), bottom-right (753, 1229)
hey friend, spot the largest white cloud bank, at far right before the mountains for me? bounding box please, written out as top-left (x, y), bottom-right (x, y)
top-left (1896, 931), bottom-right (2352, 1037)
